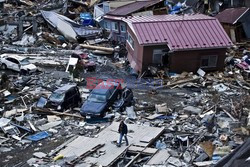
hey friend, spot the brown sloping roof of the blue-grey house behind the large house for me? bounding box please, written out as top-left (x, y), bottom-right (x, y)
top-left (107, 0), bottom-right (162, 16)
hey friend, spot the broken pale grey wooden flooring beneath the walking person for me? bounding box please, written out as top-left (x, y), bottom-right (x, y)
top-left (59, 122), bottom-right (164, 166)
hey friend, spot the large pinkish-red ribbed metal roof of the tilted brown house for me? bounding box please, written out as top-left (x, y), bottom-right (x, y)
top-left (124, 14), bottom-right (232, 50)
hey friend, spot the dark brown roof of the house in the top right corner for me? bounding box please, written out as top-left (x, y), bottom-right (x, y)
top-left (215, 7), bottom-right (249, 24)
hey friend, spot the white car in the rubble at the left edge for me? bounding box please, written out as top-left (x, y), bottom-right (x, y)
top-left (0, 53), bottom-right (37, 74)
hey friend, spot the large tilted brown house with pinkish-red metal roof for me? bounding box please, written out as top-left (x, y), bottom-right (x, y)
top-left (124, 14), bottom-right (233, 73)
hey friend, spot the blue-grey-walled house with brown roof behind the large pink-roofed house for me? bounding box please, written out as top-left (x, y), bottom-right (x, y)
top-left (100, 0), bottom-right (167, 42)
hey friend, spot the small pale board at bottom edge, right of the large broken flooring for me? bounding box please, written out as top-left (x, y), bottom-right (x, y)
top-left (147, 150), bottom-right (170, 165)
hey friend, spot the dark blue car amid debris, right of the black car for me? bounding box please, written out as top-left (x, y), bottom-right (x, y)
top-left (80, 81), bottom-right (122, 118)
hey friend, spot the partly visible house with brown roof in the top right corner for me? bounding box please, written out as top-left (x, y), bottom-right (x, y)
top-left (215, 7), bottom-right (250, 42)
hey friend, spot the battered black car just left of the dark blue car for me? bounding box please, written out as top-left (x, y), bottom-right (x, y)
top-left (46, 84), bottom-right (82, 112)
